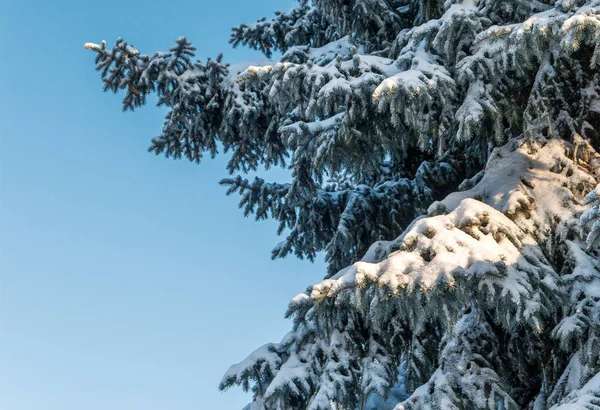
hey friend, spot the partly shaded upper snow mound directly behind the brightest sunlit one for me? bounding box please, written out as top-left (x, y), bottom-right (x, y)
top-left (436, 140), bottom-right (595, 239)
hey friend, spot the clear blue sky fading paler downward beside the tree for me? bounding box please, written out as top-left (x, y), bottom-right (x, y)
top-left (0, 0), bottom-right (324, 410)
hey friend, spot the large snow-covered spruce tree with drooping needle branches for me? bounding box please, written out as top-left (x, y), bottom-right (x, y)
top-left (85, 0), bottom-right (600, 410)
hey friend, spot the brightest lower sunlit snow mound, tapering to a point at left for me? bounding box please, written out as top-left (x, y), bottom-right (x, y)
top-left (311, 199), bottom-right (547, 319)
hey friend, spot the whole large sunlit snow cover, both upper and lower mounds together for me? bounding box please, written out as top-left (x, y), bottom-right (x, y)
top-left (308, 140), bottom-right (593, 326)
